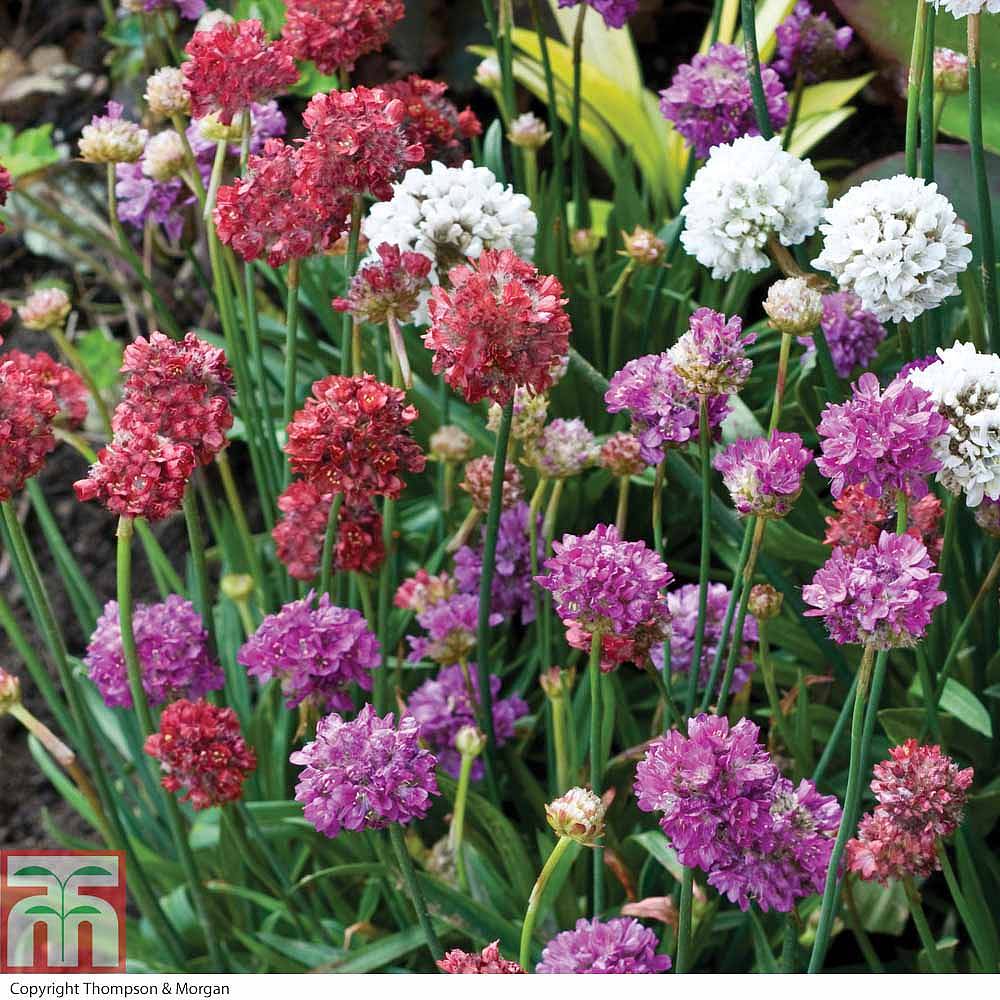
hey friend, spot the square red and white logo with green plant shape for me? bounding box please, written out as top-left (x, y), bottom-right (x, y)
top-left (0, 851), bottom-right (125, 973)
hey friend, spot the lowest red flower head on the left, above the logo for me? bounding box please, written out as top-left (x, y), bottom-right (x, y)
top-left (145, 699), bottom-right (257, 809)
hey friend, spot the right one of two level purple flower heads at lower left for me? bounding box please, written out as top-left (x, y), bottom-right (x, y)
top-left (236, 591), bottom-right (380, 712)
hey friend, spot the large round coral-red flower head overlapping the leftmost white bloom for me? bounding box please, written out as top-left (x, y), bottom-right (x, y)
top-left (424, 250), bottom-right (570, 406)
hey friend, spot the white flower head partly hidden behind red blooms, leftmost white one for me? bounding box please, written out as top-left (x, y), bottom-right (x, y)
top-left (362, 160), bottom-right (538, 323)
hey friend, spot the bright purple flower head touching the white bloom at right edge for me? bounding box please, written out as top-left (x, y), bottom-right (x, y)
top-left (816, 372), bottom-right (948, 500)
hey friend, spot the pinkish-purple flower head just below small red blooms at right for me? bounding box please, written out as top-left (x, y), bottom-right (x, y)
top-left (802, 531), bottom-right (945, 649)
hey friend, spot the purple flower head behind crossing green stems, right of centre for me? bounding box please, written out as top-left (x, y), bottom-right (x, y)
top-left (650, 583), bottom-right (758, 692)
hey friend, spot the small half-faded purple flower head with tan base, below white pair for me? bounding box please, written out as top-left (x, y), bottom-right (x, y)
top-left (667, 308), bottom-right (757, 397)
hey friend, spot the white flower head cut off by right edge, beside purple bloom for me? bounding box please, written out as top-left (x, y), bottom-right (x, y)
top-left (907, 344), bottom-right (1000, 507)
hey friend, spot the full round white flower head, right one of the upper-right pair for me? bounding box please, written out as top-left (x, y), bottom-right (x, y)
top-left (813, 174), bottom-right (972, 323)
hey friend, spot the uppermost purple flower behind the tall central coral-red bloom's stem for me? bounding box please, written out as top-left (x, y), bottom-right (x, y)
top-left (455, 500), bottom-right (545, 625)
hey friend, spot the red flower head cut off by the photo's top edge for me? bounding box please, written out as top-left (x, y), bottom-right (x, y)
top-left (281, 0), bottom-right (404, 73)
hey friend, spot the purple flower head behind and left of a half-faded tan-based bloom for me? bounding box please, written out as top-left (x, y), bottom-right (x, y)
top-left (604, 353), bottom-right (729, 465)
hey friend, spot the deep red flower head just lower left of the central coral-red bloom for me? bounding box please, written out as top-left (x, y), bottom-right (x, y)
top-left (285, 375), bottom-right (424, 502)
